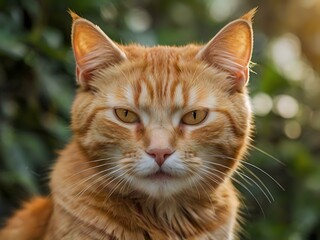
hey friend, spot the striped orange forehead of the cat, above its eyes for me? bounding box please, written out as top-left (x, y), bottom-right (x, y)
top-left (109, 51), bottom-right (214, 111)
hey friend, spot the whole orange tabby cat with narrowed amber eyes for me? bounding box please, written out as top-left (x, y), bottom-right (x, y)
top-left (0, 10), bottom-right (255, 240)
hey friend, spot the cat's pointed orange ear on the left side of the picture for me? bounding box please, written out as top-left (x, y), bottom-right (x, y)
top-left (69, 11), bottom-right (127, 86)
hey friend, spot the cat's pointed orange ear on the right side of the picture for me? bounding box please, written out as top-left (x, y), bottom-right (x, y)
top-left (197, 9), bottom-right (256, 90)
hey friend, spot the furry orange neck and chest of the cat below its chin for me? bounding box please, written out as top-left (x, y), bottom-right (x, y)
top-left (51, 142), bottom-right (237, 240)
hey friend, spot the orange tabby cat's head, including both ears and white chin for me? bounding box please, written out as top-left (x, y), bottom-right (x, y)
top-left (71, 10), bottom-right (254, 198)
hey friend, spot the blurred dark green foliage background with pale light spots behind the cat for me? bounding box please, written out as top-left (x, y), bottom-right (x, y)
top-left (0, 0), bottom-right (320, 240)
